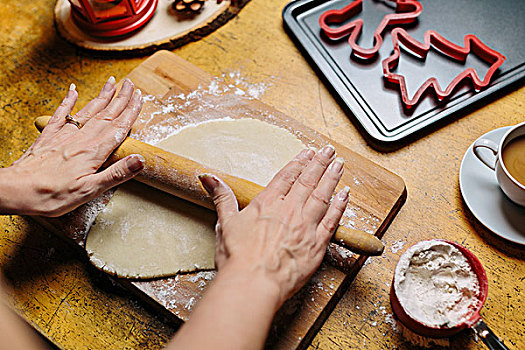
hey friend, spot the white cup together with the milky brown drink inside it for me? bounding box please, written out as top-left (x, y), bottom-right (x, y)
top-left (473, 122), bottom-right (525, 206)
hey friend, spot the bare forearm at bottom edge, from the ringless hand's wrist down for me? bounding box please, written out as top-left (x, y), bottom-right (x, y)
top-left (166, 270), bottom-right (280, 350)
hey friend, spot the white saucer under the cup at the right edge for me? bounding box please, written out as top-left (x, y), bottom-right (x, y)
top-left (459, 126), bottom-right (525, 244)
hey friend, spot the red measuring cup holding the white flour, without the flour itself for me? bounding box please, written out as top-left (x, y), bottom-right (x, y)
top-left (390, 239), bottom-right (488, 338)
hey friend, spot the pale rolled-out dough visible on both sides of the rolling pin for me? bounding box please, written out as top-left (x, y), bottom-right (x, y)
top-left (86, 118), bottom-right (305, 278)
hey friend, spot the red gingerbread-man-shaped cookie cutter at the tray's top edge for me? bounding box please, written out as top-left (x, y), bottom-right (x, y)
top-left (319, 0), bottom-right (423, 59)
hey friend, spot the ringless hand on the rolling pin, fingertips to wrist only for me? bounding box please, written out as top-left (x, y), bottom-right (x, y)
top-left (200, 146), bottom-right (349, 306)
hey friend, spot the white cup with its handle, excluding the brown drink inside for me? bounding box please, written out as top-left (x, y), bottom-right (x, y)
top-left (474, 122), bottom-right (525, 206)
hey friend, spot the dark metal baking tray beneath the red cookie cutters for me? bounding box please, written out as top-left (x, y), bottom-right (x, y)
top-left (283, 0), bottom-right (525, 150)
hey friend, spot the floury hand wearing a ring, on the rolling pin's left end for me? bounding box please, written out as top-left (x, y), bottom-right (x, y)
top-left (0, 77), bottom-right (144, 216)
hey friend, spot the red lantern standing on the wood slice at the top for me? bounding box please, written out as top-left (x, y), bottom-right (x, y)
top-left (69, 0), bottom-right (158, 37)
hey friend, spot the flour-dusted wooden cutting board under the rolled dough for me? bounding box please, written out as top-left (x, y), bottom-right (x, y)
top-left (37, 51), bottom-right (406, 349)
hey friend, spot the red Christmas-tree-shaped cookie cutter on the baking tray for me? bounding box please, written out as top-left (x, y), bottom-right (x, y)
top-left (382, 28), bottom-right (505, 108)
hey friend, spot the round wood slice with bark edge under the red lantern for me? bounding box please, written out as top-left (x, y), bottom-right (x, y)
top-left (55, 0), bottom-right (249, 55)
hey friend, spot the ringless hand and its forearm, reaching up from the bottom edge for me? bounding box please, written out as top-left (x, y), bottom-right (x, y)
top-left (171, 146), bottom-right (349, 350)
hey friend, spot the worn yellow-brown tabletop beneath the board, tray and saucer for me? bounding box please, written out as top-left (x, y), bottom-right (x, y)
top-left (0, 0), bottom-right (525, 350)
